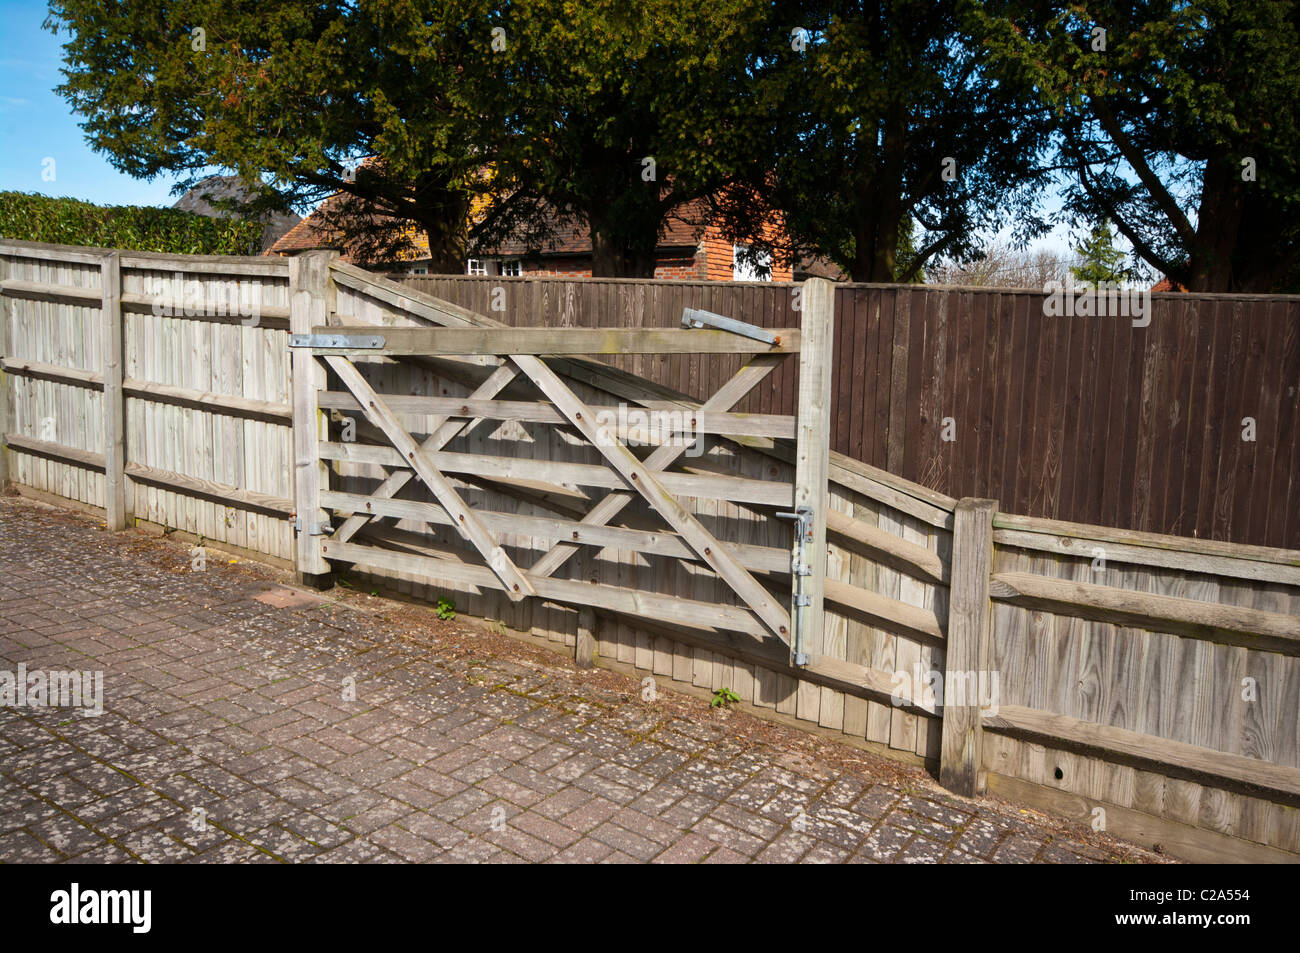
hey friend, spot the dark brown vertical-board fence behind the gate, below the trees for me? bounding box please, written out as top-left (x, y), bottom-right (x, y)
top-left (395, 276), bottom-right (1300, 549)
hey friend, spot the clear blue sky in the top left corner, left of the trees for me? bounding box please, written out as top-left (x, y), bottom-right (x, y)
top-left (0, 0), bottom-right (189, 205)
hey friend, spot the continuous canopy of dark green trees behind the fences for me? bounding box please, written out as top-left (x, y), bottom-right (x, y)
top-left (47, 0), bottom-right (1300, 291)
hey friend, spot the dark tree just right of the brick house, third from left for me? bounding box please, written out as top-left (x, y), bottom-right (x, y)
top-left (712, 0), bottom-right (1047, 281)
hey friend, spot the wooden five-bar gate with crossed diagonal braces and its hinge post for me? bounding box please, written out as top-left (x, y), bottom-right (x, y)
top-left (289, 255), bottom-right (831, 666)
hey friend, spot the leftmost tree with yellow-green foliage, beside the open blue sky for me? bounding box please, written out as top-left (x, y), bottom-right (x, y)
top-left (47, 0), bottom-right (510, 270)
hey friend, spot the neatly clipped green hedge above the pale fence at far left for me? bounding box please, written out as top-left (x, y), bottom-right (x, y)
top-left (0, 192), bottom-right (261, 255)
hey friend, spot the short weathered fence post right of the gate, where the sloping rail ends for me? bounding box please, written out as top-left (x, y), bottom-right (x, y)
top-left (936, 498), bottom-right (997, 797)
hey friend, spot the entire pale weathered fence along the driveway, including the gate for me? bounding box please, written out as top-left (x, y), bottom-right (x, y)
top-left (0, 243), bottom-right (1300, 861)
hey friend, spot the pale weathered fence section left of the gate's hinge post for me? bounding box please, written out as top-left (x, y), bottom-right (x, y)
top-left (0, 237), bottom-right (294, 560)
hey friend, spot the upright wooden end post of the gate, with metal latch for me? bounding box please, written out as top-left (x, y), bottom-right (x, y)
top-left (790, 278), bottom-right (835, 664)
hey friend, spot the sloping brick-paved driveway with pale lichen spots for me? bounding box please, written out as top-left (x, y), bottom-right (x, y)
top-left (0, 498), bottom-right (1158, 863)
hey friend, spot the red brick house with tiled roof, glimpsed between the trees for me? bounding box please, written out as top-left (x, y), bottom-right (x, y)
top-left (267, 192), bottom-right (796, 281)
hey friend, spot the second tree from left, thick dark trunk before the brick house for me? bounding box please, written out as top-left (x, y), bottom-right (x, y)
top-left (481, 0), bottom-right (772, 276)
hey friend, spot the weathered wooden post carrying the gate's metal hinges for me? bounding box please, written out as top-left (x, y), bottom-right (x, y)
top-left (289, 251), bottom-right (338, 589)
